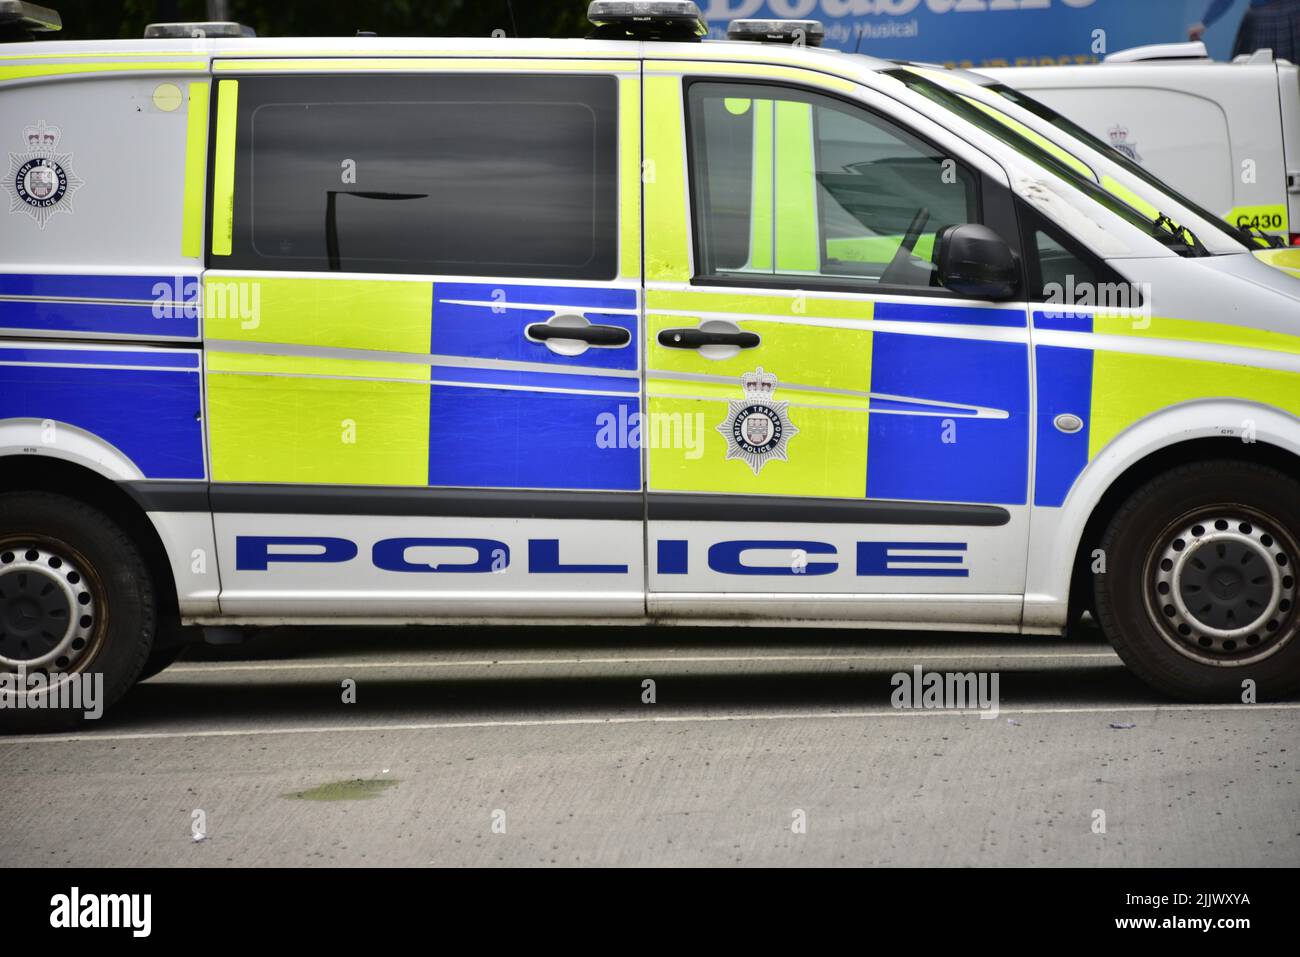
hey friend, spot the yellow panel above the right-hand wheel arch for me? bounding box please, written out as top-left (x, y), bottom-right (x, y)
top-left (1088, 351), bottom-right (1300, 459)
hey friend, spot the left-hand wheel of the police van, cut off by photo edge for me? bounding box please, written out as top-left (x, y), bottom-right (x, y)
top-left (0, 492), bottom-right (157, 733)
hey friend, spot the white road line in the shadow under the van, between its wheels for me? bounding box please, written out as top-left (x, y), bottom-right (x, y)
top-left (160, 651), bottom-right (1119, 675)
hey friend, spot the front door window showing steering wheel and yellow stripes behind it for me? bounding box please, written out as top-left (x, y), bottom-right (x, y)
top-left (689, 82), bottom-right (980, 287)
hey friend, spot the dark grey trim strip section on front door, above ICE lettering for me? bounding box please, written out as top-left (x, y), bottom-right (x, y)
top-left (647, 493), bottom-right (1011, 527)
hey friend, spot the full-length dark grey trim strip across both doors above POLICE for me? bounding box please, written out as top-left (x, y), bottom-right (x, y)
top-left (122, 481), bottom-right (1011, 527)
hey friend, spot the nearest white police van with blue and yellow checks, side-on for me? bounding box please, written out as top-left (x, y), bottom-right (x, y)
top-left (0, 0), bottom-right (1300, 727)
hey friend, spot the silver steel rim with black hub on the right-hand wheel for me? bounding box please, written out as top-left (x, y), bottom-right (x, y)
top-left (1144, 506), bottom-right (1297, 667)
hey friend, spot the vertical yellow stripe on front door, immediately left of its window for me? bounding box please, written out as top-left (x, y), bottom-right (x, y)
top-left (645, 77), bottom-right (690, 282)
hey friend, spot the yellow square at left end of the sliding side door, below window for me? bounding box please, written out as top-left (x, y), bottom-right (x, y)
top-left (204, 276), bottom-right (433, 485)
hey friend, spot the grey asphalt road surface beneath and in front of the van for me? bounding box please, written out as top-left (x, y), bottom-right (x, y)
top-left (0, 628), bottom-right (1300, 866)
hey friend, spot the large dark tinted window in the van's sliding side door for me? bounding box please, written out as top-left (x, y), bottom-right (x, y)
top-left (222, 74), bottom-right (618, 280)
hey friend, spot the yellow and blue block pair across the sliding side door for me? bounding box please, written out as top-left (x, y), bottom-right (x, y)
top-left (204, 274), bottom-right (641, 490)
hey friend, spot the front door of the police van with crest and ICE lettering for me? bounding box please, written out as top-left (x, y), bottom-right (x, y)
top-left (646, 66), bottom-right (1030, 625)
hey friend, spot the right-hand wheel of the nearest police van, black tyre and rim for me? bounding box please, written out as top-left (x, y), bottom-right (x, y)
top-left (1093, 459), bottom-right (1300, 701)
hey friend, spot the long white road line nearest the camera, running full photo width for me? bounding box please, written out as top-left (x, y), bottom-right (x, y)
top-left (0, 702), bottom-right (1300, 745)
